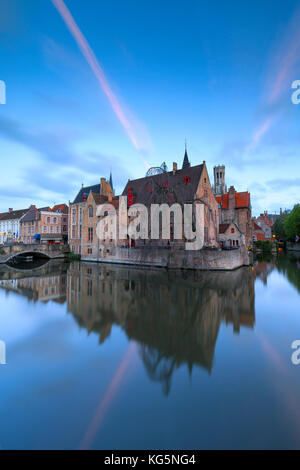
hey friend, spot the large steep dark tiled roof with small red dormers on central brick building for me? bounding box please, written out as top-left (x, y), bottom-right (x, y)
top-left (123, 165), bottom-right (203, 207)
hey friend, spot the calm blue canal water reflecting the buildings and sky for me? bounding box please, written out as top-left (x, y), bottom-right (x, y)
top-left (0, 253), bottom-right (300, 449)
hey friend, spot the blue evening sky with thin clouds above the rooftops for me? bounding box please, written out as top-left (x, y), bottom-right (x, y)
top-left (0, 0), bottom-right (300, 214)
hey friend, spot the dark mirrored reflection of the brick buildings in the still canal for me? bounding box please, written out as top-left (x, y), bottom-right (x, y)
top-left (0, 262), bottom-right (255, 393)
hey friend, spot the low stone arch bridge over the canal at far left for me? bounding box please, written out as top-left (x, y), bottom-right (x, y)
top-left (0, 244), bottom-right (69, 264)
